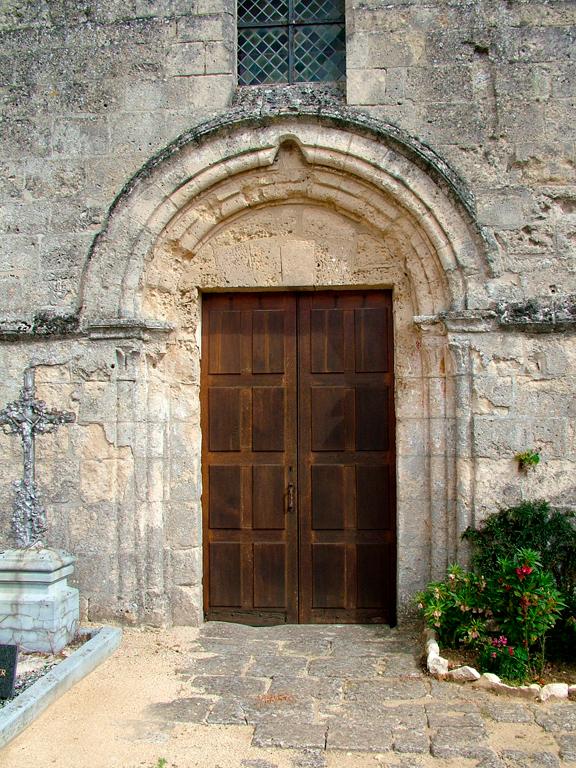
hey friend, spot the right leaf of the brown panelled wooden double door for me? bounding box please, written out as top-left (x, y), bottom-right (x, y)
top-left (298, 291), bottom-right (396, 623)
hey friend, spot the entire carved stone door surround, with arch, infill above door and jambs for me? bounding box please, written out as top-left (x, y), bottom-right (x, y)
top-left (77, 111), bottom-right (490, 623)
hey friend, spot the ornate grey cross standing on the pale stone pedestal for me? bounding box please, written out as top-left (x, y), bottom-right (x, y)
top-left (0, 368), bottom-right (75, 547)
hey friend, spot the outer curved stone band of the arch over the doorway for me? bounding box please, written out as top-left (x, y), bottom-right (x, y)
top-left (81, 114), bottom-right (490, 323)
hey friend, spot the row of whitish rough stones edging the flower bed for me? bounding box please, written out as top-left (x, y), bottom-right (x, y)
top-left (424, 627), bottom-right (576, 702)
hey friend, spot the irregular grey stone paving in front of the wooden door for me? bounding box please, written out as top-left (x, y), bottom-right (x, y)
top-left (154, 622), bottom-right (576, 768)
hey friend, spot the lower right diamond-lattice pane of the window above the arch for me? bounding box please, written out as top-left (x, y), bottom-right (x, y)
top-left (294, 24), bottom-right (346, 83)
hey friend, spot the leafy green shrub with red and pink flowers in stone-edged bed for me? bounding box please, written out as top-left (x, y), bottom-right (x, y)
top-left (417, 549), bottom-right (564, 681)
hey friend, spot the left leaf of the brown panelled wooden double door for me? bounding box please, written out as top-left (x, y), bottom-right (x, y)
top-left (202, 294), bottom-right (298, 624)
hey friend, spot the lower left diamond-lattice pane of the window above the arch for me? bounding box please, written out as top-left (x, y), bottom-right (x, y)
top-left (238, 28), bottom-right (288, 85)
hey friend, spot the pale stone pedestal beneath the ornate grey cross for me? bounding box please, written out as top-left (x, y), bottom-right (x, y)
top-left (0, 545), bottom-right (80, 653)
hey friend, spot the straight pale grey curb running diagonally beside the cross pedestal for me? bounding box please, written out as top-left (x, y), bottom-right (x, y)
top-left (0, 627), bottom-right (122, 749)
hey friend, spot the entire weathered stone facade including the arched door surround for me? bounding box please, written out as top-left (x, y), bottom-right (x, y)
top-left (0, 0), bottom-right (576, 624)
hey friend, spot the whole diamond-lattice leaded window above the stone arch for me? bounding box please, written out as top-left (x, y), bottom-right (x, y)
top-left (238, 0), bottom-right (346, 85)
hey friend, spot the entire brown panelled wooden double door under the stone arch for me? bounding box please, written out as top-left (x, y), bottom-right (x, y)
top-left (202, 291), bottom-right (396, 625)
